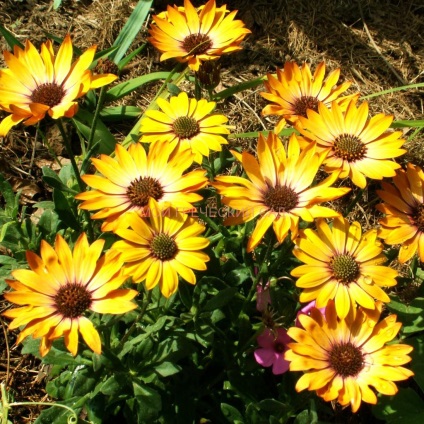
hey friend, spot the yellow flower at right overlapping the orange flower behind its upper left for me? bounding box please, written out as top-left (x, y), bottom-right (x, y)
top-left (296, 100), bottom-right (406, 188)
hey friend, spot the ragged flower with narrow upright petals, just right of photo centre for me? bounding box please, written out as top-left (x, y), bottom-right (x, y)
top-left (213, 133), bottom-right (350, 252)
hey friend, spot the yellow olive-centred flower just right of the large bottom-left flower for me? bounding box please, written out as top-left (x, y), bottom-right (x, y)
top-left (113, 199), bottom-right (209, 297)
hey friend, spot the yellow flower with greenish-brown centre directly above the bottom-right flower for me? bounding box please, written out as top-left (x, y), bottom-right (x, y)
top-left (291, 217), bottom-right (398, 318)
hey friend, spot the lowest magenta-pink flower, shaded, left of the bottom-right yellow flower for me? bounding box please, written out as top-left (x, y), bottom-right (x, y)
top-left (254, 328), bottom-right (291, 375)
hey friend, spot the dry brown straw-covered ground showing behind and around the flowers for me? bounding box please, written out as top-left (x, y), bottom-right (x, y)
top-left (0, 0), bottom-right (424, 423)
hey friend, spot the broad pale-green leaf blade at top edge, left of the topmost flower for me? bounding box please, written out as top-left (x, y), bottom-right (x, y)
top-left (110, 0), bottom-right (153, 63)
